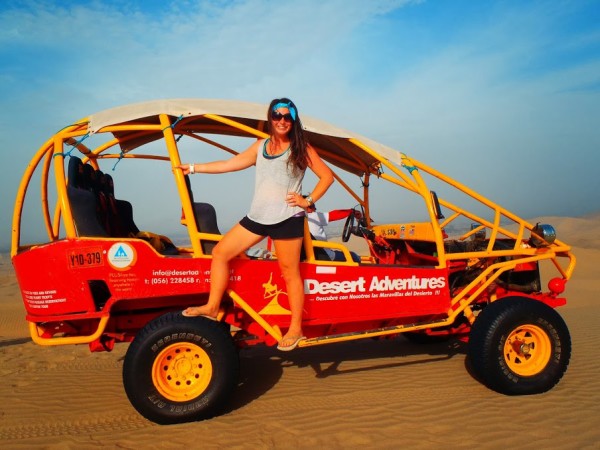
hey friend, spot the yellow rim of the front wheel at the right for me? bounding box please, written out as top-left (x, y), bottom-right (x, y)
top-left (504, 325), bottom-right (552, 377)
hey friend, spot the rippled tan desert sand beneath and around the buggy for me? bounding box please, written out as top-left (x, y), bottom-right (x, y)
top-left (0, 215), bottom-right (600, 449)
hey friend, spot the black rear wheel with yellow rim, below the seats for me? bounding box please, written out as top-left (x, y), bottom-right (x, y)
top-left (123, 313), bottom-right (239, 424)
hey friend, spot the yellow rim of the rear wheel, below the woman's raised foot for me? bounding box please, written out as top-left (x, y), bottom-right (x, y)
top-left (152, 342), bottom-right (213, 402)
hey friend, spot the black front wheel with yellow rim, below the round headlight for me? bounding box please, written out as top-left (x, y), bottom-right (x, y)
top-left (468, 297), bottom-right (571, 395)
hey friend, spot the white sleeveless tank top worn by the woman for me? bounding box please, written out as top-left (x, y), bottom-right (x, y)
top-left (248, 139), bottom-right (304, 225)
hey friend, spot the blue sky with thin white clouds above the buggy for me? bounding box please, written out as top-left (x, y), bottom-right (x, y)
top-left (0, 0), bottom-right (600, 250)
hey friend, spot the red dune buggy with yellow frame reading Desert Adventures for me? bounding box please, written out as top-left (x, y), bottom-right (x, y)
top-left (11, 99), bottom-right (575, 424)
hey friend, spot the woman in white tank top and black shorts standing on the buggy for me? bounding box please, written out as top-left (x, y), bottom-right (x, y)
top-left (179, 98), bottom-right (333, 351)
